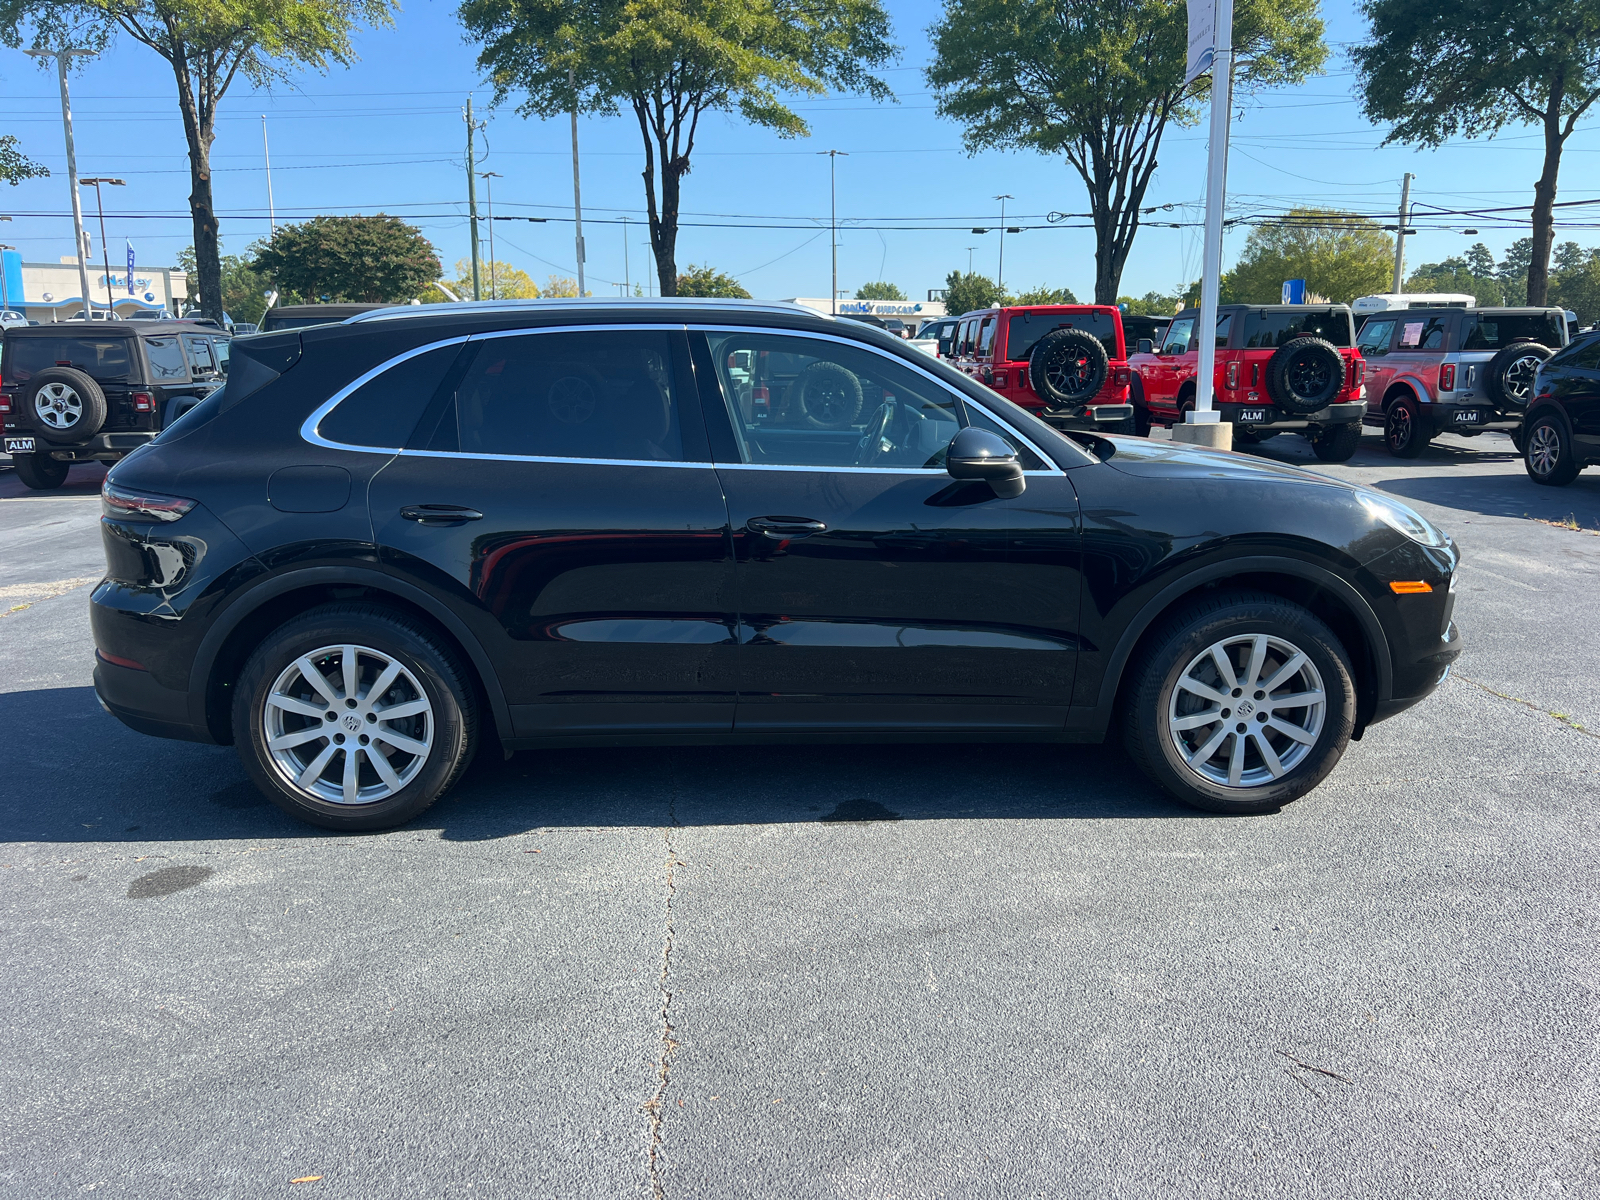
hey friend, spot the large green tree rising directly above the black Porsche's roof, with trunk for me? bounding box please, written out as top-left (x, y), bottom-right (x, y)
top-left (459, 0), bottom-right (896, 296)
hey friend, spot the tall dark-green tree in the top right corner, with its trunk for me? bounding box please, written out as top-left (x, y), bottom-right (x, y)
top-left (1352, 0), bottom-right (1600, 304)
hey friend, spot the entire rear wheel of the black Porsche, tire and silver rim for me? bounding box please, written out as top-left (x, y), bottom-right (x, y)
top-left (234, 605), bottom-right (477, 832)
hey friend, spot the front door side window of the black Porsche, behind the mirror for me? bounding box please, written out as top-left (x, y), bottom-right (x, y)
top-left (707, 333), bottom-right (963, 470)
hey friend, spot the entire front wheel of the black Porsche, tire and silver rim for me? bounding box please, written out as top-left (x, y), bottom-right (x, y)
top-left (1123, 592), bottom-right (1355, 813)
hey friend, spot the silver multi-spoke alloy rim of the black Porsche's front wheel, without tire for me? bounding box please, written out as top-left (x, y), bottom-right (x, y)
top-left (1166, 634), bottom-right (1328, 787)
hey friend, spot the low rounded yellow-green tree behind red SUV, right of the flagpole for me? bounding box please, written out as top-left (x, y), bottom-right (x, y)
top-left (1221, 208), bottom-right (1395, 304)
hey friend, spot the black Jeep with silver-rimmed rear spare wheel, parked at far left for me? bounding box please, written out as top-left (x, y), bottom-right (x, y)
top-left (0, 322), bottom-right (230, 488)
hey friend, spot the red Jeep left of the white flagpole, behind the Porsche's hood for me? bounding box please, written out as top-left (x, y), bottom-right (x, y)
top-left (952, 304), bottom-right (1134, 434)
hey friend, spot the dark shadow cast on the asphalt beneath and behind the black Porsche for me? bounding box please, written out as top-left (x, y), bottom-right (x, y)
top-left (0, 688), bottom-right (1206, 845)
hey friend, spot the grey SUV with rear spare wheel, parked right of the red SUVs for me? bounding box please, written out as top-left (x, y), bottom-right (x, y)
top-left (1358, 306), bottom-right (1568, 458)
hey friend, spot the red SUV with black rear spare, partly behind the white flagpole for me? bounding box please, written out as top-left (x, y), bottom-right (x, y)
top-left (1128, 304), bottom-right (1366, 462)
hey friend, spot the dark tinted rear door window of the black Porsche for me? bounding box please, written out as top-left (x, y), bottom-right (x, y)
top-left (429, 330), bottom-right (683, 462)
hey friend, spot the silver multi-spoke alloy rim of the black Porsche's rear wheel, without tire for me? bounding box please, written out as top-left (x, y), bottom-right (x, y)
top-left (261, 645), bottom-right (434, 805)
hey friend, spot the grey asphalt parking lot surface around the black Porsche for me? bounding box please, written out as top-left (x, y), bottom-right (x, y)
top-left (0, 430), bottom-right (1600, 1200)
